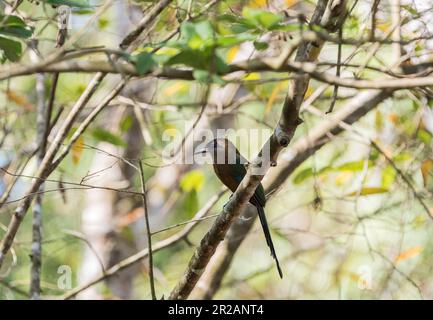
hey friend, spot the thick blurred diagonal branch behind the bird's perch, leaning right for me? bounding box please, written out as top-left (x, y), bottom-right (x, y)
top-left (192, 90), bottom-right (392, 299)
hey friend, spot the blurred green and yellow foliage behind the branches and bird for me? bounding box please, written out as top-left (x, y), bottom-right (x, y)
top-left (0, 0), bottom-right (433, 299)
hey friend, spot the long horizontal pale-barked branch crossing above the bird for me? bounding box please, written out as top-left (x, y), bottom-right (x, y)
top-left (0, 50), bottom-right (433, 89)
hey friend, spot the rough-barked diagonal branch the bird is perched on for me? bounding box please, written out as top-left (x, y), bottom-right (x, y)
top-left (169, 0), bottom-right (345, 300)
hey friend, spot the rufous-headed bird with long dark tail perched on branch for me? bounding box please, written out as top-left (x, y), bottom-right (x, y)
top-left (195, 138), bottom-right (283, 278)
